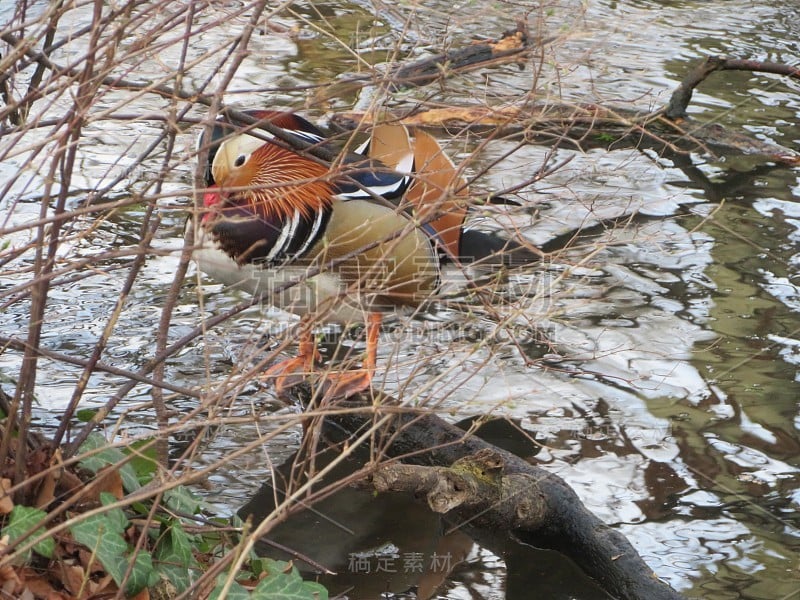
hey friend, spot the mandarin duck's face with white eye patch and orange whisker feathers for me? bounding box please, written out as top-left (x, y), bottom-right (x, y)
top-left (206, 134), bottom-right (333, 218)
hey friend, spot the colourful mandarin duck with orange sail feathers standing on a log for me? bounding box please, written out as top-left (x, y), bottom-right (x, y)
top-left (194, 110), bottom-right (532, 397)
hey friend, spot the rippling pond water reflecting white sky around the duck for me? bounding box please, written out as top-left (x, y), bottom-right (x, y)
top-left (0, 0), bottom-right (800, 599)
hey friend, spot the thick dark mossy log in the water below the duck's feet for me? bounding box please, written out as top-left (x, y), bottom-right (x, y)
top-left (295, 386), bottom-right (682, 600)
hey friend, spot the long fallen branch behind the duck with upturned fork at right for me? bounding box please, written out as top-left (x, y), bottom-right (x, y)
top-left (332, 56), bottom-right (800, 164)
